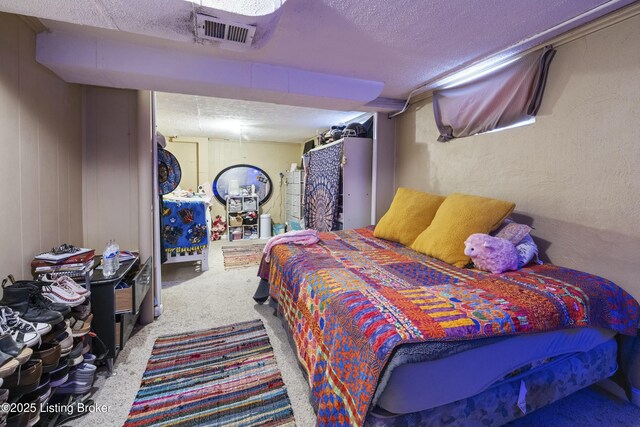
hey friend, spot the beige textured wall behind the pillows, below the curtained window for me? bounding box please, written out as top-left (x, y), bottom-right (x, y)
top-left (395, 16), bottom-right (640, 299)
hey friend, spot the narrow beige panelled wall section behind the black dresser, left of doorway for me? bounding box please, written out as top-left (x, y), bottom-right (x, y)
top-left (82, 86), bottom-right (139, 253)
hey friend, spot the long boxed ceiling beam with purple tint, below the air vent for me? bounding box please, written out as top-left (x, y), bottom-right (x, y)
top-left (36, 32), bottom-right (384, 110)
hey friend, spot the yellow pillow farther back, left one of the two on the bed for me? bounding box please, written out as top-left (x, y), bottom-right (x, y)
top-left (373, 187), bottom-right (445, 246)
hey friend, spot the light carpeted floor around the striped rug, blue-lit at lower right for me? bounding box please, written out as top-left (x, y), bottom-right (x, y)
top-left (72, 241), bottom-right (640, 427)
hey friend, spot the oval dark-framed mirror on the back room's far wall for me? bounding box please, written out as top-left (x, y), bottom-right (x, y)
top-left (212, 165), bottom-right (273, 205)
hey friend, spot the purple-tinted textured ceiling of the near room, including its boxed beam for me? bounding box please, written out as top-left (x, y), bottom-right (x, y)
top-left (0, 0), bottom-right (633, 140)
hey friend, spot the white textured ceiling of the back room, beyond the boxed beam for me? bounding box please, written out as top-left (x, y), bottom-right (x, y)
top-left (156, 92), bottom-right (362, 143)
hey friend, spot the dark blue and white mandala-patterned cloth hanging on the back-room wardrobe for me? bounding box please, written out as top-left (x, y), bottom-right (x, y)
top-left (304, 142), bottom-right (343, 231)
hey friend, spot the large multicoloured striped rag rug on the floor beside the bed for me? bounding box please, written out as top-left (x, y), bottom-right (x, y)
top-left (124, 320), bottom-right (295, 427)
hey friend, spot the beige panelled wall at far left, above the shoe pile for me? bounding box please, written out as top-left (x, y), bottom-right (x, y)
top-left (0, 13), bottom-right (83, 278)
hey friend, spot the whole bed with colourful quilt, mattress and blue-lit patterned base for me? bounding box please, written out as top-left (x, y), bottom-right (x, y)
top-left (259, 227), bottom-right (638, 426)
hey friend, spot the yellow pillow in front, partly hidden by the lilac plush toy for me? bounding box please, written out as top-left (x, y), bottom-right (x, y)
top-left (411, 193), bottom-right (516, 267)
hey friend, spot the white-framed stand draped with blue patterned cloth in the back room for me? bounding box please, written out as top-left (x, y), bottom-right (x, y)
top-left (162, 195), bottom-right (211, 271)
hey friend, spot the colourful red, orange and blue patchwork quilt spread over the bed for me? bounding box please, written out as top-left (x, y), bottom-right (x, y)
top-left (259, 228), bottom-right (639, 426)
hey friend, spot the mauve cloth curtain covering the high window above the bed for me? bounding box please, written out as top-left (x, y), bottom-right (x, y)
top-left (433, 46), bottom-right (555, 142)
